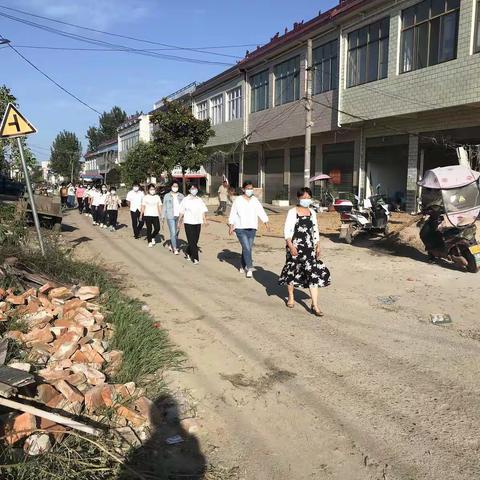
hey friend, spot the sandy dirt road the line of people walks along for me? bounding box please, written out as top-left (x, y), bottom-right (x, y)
top-left (64, 212), bottom-right (480, 480)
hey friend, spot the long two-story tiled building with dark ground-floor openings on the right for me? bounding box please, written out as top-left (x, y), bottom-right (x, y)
top-left (194, 0), bottom-right (480, 210)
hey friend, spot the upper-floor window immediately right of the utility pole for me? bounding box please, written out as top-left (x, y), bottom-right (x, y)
top-left (313, 40), bottom-right (338, 95)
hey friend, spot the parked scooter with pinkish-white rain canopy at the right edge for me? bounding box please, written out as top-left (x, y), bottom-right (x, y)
top-left (419, 165), bottom-right (480, 273)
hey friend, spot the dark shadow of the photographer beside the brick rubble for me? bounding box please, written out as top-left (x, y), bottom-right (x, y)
top-left (116, 395), bottom-right (207, 480)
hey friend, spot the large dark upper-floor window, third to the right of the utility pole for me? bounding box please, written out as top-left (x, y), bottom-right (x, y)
top-left (400, 0), bottom-right (460, 73)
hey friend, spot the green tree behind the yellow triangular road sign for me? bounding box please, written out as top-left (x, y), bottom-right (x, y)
top-left (0, 85), bottom-right (37, 173)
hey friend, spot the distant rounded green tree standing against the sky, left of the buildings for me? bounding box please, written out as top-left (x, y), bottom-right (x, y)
top-left (50, 130), bottom-right (82, 180)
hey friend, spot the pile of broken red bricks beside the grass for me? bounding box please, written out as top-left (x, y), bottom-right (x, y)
top-left (0, 283), bottom-right (159, 455)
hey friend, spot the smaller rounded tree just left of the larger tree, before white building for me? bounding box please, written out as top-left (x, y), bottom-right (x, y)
top-left (121, 142), bottom-right (165, 184)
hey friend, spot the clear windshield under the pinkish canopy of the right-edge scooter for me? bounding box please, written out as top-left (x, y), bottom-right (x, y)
top-left (442, 182), bottom-right (480, 227)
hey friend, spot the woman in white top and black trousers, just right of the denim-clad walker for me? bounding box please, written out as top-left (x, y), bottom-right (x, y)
top-left (178, 185), bottom-right (208, 265)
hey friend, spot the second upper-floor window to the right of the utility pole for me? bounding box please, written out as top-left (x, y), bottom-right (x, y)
top-left (347, 17), bottom-right (390, 87)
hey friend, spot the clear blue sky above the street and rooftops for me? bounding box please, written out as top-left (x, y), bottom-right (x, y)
top-left (0, 0), bottom-right (338, 161)
